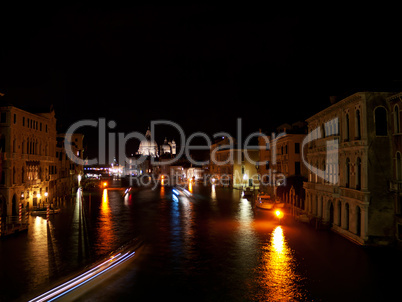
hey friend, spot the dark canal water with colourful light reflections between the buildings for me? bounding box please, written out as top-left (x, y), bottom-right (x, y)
top-left (0, 180), bottom-right (402, 301)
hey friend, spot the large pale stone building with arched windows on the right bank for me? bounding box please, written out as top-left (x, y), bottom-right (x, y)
top-left (304, 92), bottom-right (395, 244)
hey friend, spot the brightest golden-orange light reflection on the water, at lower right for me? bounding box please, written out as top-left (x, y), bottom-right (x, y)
top-left (260, 226), bottom-right (304, 301)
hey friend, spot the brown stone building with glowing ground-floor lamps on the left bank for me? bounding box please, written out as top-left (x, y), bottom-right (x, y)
top-left (0, 105), bottom-right (83, 223)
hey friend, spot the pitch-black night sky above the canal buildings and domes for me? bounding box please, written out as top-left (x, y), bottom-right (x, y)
top-left (0, 2), bottom-right (402, 159)
